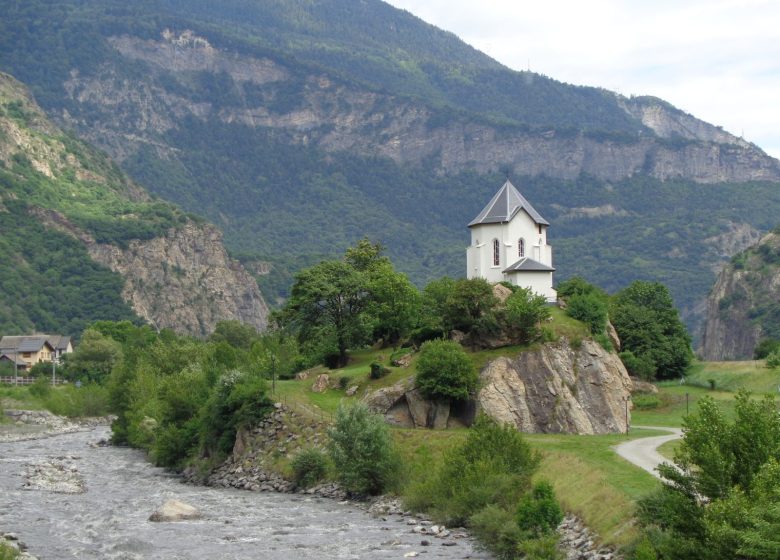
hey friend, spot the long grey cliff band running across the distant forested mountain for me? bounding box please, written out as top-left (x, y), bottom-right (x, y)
top-left (61, 30), bottom-right (780, 183)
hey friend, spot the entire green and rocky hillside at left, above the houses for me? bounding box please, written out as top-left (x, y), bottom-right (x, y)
top-left (0, 74), bottom-right (267, 335)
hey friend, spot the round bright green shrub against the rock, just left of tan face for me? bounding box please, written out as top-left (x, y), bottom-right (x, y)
top-left (417, 339), bottom-right (479, 401)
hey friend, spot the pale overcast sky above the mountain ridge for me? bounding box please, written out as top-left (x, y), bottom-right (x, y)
top-left (388, 0), bottom-right (780, 158)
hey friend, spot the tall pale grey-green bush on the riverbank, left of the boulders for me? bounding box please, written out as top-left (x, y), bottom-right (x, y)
top-left (328, 403), bottom-right (401, 495)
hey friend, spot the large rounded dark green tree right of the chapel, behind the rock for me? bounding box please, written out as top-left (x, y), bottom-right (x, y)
top-left (609, 281), bottom-right (693, 379)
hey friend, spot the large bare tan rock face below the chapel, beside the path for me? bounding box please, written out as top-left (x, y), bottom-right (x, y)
top-left (478, 340), bottom-right (631, 434)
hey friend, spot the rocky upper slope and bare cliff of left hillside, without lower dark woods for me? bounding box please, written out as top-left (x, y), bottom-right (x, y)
top-left (0, 74), bottom-right (268, 336)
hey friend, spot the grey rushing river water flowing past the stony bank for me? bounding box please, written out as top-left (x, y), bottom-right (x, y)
top-left (0, 428), bottom-right (487, 560)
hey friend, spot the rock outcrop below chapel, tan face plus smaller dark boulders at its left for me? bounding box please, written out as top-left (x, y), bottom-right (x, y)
top-left (365, 340), bottom-right (632, 434)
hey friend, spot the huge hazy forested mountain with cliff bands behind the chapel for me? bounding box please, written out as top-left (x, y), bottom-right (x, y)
top-left (0, 0), bottom-right (780, 332)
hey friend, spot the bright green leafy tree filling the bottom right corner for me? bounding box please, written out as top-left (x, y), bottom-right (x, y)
top-left (639, 392), bottom-right (780, 559)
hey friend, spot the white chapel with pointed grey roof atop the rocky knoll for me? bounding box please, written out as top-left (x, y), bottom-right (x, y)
top-left (466, 179), bottom-right (558, 303)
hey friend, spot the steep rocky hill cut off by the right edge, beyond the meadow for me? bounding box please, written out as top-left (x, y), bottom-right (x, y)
top-left (699, 233), bottom-right (780, 360)
